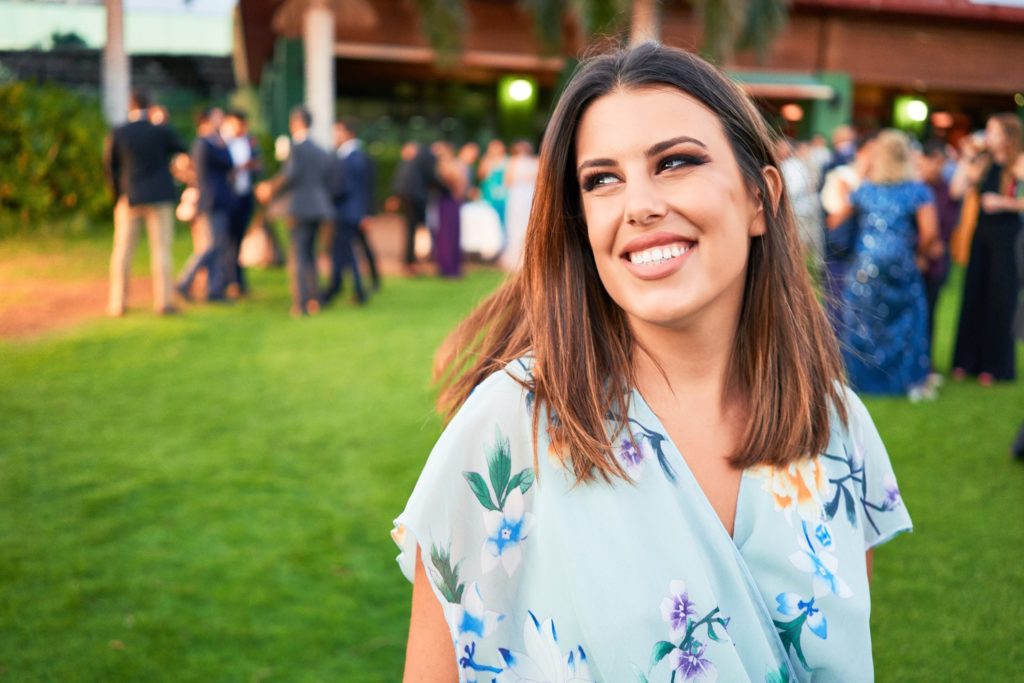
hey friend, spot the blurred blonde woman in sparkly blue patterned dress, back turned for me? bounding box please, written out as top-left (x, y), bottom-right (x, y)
top-left (829, 130), bottom-right (942, 399)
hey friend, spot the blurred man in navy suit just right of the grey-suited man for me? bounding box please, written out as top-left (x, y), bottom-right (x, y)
top-left (324, 121), bottom-right (379, 304)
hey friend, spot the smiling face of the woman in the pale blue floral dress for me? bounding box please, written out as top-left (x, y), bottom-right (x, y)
top-left (575, 87), bottom-right (778, 335)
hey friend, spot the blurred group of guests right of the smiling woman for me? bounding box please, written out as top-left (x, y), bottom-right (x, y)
top-left (777, 114), bottom-right (1024, 400)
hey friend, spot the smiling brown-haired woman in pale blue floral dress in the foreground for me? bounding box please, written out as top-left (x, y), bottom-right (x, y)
top-left (392, 43), bottom-right (910, 683)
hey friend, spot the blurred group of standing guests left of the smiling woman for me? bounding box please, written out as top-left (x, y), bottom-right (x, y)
top-left (105, 91), bottom-right (538, 316)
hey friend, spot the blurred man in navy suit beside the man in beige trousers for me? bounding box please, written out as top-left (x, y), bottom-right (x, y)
top-left (176, 108), bottom-right (234, 301)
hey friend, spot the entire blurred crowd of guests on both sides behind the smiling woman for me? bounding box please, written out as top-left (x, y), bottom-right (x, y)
top-left (99, 92), bottom-right (1024, 413)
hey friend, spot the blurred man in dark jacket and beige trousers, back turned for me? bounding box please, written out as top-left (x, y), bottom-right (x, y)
top-left (104, 90), bottom-right (185, 316)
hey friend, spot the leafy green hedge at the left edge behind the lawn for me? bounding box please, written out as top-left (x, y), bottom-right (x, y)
top-left (0, 81), bottom-right (112, 234)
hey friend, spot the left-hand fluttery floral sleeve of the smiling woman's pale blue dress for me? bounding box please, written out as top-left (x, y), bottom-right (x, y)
top-left (392, 369), bottom-right (537, 680)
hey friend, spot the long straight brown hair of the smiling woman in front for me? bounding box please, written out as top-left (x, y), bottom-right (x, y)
top-left (434, 43), bottom-right (846, 481)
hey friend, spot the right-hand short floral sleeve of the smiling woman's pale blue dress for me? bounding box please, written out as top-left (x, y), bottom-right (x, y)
top-left (846, 389), bottom-right (913, 550)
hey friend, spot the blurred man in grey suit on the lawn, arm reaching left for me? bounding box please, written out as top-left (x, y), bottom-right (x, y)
top-left (256, 106), bottom-right (333, 316)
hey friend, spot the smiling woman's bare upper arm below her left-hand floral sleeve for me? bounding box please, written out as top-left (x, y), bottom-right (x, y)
top-left (402, 553), bottom-right (459, 683)
